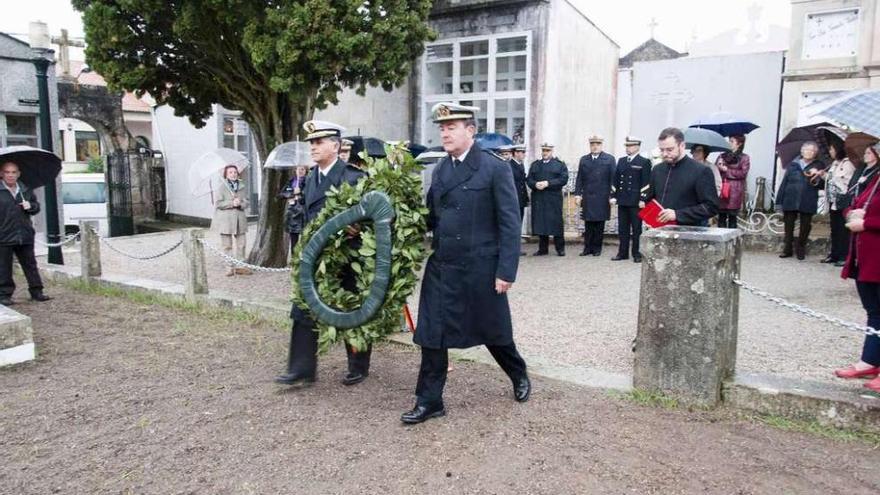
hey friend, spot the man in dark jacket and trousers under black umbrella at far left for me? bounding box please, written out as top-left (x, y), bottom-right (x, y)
top-left (0, 162), bottom-right (51, 306)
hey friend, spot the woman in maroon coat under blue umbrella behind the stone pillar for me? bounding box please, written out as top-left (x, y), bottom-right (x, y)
top-left (715, 135), bottom-right (751, 229)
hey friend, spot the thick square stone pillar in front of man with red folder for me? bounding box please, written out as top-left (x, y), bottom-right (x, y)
top-left (633, 226), bottom-right (742, 407)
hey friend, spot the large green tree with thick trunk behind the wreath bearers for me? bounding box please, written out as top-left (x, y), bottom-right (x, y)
top-left (72, 0), bottom-right (433, 266)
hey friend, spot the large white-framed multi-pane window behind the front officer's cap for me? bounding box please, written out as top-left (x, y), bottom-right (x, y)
top-left (421, 34), bottom-right (530, 146)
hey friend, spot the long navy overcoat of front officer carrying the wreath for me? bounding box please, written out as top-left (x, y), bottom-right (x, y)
top-left (413, 144), bottom-right (520, 349)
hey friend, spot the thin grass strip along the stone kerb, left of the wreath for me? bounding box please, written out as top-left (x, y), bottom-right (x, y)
top-left (58, 279), bottom-right (290, 331)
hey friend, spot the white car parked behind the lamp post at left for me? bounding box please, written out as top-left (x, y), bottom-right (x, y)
top-left (61, 174), bottom-right (110, 236)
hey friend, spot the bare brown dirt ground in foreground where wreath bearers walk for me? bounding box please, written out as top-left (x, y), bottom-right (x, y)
top-left (0, 286), bottom-right (880, 495)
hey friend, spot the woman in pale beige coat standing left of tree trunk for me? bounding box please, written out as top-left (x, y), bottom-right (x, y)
top-left (211, 165), bottom-right (251, 276)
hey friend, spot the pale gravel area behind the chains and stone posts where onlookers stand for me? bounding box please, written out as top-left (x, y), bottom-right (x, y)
top-left (43, 226), bottom-right (864, 387)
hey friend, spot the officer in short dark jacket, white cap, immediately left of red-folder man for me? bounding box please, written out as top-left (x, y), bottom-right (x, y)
top-left (611, 136), bottom-right (651, 263)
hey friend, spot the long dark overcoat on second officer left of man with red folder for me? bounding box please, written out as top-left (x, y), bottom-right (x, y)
top-left (574, 151), bottom-right (615, 222)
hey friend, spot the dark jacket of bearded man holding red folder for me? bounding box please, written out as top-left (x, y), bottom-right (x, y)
top-left (646, 156), bottom-right (718, 226)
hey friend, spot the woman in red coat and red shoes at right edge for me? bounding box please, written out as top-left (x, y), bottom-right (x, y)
top-left (834, 145), bottom-right (880, 392)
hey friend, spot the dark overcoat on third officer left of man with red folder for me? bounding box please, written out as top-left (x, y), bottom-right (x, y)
top-left (526, 158), bottom-right (568, 236)
